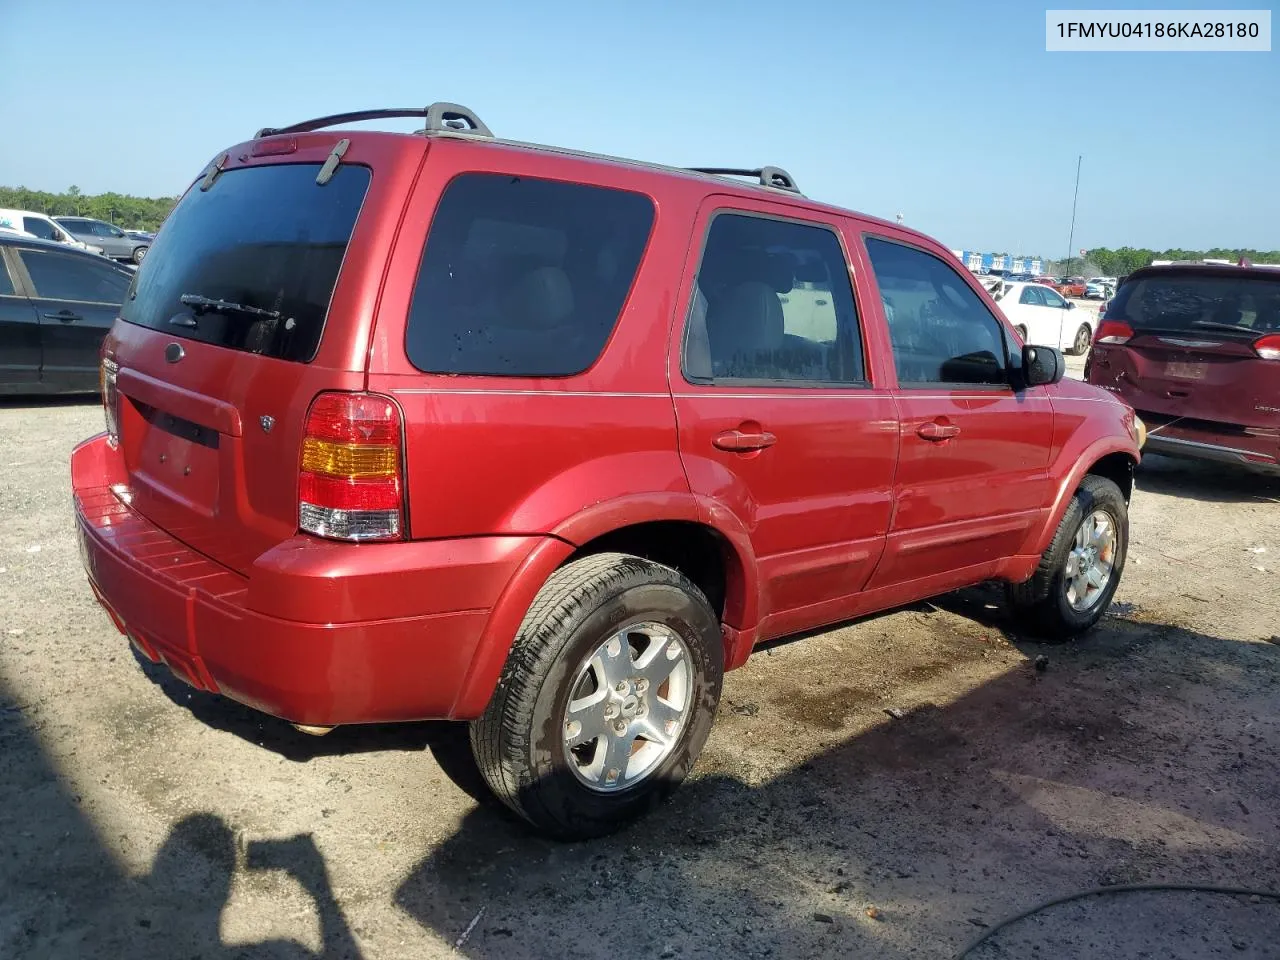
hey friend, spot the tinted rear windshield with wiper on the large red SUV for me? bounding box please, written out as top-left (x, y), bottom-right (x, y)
top-left (120, 164), bottom-right (370, 362)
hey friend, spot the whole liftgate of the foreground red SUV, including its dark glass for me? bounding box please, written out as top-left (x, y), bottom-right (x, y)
top-left (113, 163), bottom-right (371, 572)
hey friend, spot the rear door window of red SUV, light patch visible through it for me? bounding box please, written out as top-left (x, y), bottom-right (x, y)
top-left (684, 214), bottom-right (864, 385)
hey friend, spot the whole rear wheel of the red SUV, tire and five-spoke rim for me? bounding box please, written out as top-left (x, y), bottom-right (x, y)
top-left (471, 553), bottom-right (724, 840)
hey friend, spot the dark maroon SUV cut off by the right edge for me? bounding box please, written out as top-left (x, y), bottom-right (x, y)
top-left (1085, 264), bottom-right (1280, 471)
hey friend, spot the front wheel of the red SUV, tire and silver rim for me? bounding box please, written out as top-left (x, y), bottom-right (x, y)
top-left (1009, 475), bottom-right (1129, 643)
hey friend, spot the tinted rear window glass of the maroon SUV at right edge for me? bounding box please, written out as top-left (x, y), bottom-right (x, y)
top-left (1107, 271), bottom-right (1280, 337)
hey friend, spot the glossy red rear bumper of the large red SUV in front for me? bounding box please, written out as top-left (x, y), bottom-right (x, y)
top-left (72, 436), bottom-right (540, 726)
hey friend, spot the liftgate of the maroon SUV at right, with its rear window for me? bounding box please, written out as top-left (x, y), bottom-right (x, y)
top-left (1091, 270), bottom-right (1280, 426)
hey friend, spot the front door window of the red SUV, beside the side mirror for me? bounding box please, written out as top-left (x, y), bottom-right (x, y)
top-left (867, 237), bottom-right (1009, 385)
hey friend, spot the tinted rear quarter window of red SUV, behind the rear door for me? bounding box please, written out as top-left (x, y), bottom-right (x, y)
top-left (404, 173), bottom-right (653, 376)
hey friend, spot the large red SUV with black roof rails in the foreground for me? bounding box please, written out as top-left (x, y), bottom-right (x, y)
top-left (72, 105), bottom-right (1140, 837)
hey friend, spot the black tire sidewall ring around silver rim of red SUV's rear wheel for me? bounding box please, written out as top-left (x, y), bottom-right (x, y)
top-left (521, 582), bottom-right (724, 836)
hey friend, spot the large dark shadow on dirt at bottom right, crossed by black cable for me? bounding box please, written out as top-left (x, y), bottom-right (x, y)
top-left (397, 604), bottom-right (1280, 959)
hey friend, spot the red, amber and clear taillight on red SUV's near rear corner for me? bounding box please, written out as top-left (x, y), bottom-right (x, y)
top-left (298, 393), bottom-right (404, 540)
